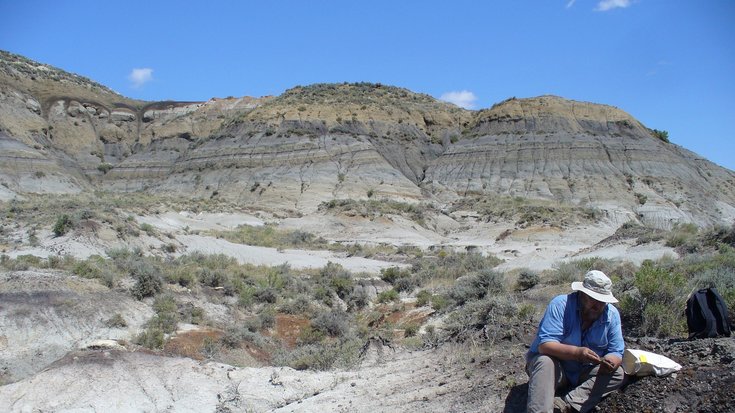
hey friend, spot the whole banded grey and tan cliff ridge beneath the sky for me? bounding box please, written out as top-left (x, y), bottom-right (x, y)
top-left (0, 52), bottom-right (735, 227)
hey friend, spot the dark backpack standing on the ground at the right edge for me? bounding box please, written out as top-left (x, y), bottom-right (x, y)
top-left (686, 288), bottom-right (730, 339)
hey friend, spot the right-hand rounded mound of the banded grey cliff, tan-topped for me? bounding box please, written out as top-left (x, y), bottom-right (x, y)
top-left (427, 96), bottom-right (735, 227)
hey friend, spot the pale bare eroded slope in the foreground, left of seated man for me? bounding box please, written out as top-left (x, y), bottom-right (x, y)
top-left (0, 336), bottom-right (523, 413)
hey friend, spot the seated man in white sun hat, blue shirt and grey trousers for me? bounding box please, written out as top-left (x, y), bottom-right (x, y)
top-left (526, 271), bottom-right (624, 413)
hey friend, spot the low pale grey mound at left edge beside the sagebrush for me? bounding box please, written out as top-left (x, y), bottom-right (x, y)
top-left (0, 271), bottom-right (152, 384)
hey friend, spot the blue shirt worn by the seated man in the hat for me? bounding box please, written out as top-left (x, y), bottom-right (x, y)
top-left (527, 292), bottom-right (625, 385)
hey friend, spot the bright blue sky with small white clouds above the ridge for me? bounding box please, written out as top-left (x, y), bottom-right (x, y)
top-left (0, 0), bottom-right (735, 170)
